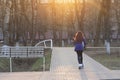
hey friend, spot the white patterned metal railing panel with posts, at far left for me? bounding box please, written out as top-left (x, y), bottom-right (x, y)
top-left (0, 46), bottom-right (45, 72)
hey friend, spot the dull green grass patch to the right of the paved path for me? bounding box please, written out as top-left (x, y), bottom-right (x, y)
top-left (86, 51), bottom-right (120, 70)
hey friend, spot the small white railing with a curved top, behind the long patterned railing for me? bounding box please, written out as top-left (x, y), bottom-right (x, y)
top-left (35, 39), bottom-right (53, 49)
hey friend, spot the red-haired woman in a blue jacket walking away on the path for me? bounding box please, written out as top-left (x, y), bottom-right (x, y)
top-left (74, 31), bottom-right (86, 69)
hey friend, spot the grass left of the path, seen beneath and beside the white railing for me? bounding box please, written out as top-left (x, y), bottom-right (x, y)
top-left (0, 49), bottom-right (52, 72)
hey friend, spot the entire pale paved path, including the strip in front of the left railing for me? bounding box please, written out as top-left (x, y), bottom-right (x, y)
top-left (0, 47), bottom-right (120, 80)
